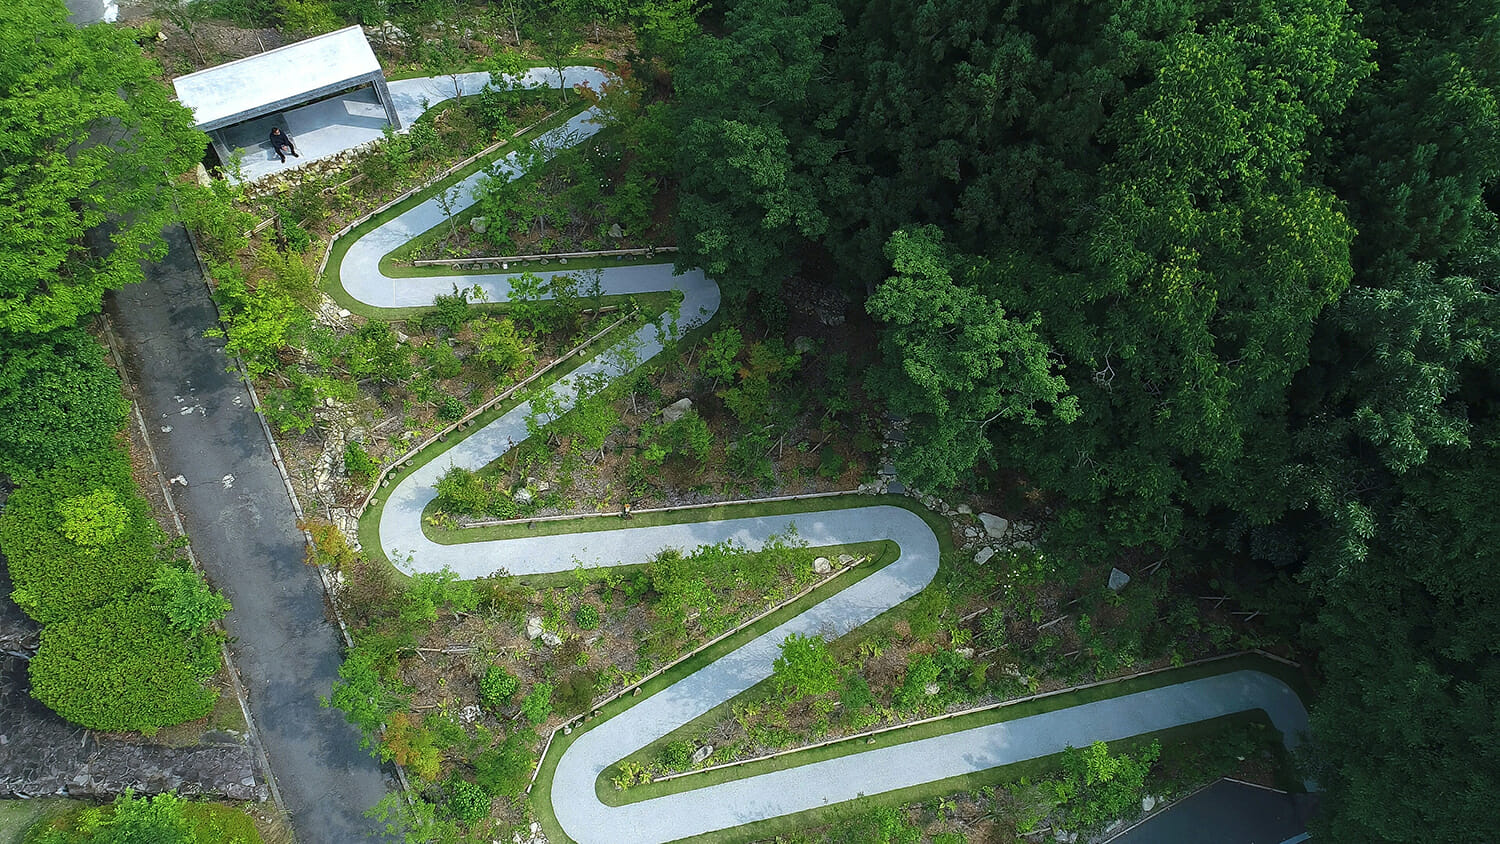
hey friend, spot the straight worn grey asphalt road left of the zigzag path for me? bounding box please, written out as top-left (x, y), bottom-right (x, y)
top-left (107, 226), bottom-right (395, 844)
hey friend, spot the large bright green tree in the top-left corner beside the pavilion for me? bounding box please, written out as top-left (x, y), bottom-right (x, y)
top-left (0, 0), bottom-right (207, 333)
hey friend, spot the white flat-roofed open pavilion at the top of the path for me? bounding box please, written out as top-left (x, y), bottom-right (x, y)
top-left (173, 25), bottom-right (402, 180)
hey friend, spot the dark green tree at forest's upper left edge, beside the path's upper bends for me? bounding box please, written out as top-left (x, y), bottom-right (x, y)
top-left (675, 0), bottom-right (848, 301)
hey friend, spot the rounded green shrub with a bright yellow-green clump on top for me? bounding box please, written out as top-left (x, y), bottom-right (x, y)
top-left (0, 447), bottom-right (165, 624)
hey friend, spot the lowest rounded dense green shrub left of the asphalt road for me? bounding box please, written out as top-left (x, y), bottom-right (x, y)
top-left (30, 594), bottom-right (218, 735)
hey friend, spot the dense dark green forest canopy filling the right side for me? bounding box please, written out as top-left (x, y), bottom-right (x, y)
top-left (675, 0), bottom-right (1500, 841)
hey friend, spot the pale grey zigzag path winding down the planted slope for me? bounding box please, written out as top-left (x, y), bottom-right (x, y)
top-left (339, 67), bottom-right (1307, 844)
